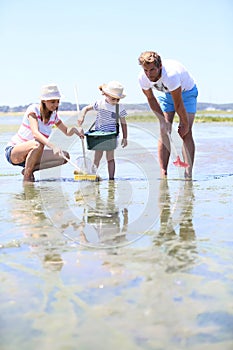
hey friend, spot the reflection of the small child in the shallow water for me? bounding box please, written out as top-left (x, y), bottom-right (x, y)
top-left (62, 181), bottom-right (128, 247)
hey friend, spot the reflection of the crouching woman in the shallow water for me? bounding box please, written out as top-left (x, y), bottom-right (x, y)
top-left (11, 183), bottom-right (63, 271)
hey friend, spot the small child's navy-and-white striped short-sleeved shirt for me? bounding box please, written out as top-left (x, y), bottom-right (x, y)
top-left (93, 99), bottom-right (127, 132)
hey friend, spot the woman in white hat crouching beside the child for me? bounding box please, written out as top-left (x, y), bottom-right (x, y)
top-left (5, 85), bottom-right (84, 182)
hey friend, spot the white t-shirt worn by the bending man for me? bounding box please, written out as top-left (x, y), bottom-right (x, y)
top-left (139, 59), bottom-right (195, 93)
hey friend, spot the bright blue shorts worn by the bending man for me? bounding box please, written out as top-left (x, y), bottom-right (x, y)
top-left (157, 85), bottom-right (198, 113)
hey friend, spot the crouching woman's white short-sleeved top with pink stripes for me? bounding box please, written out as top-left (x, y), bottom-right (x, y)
top-left (8, 104), bottom-right (60, 146)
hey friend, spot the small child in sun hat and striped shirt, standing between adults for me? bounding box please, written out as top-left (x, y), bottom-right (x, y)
top-left (78, 81), bottom-right (127, 180)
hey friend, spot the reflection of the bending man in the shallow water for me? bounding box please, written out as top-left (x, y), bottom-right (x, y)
top-left (154, 180), bottom-right (197, 272)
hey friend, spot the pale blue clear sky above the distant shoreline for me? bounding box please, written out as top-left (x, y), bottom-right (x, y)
top-left (0, 0), bottom-right (233, 107)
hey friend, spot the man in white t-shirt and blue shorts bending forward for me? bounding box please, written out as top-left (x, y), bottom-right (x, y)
top-left (139, 51), bottom-right (198, 178)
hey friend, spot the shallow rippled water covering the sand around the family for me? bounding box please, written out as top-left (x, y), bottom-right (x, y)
top-left (0, 118), bottom-right (233, 350)
